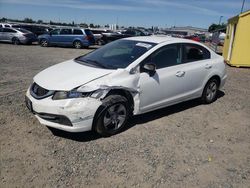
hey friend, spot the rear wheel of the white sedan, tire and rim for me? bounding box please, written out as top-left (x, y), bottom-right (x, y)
top-left (201, 78), bottom-right (219, 104)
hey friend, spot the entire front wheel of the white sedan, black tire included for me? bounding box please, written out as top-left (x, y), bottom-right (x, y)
top-left (94, 95), bottom-right (130, 137)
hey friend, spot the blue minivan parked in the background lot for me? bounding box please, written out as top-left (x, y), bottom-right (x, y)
top-left (38, 28), bottom-right (95, 49)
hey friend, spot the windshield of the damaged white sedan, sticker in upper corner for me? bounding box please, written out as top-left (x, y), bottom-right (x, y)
top-left (75, 40), bottom-right (156, 69)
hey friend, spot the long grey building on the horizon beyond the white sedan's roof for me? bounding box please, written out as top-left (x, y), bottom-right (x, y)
top-left (164, 26), bottom-right (209, 37)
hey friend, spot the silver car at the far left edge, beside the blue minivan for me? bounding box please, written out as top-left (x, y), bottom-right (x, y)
top-left (0, 28), bottom-right (37, 44)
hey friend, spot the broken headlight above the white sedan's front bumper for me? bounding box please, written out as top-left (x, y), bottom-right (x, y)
top-left (52, 90), bottom-right (104, 100)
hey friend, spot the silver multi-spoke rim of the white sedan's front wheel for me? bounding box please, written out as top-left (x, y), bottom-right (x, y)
top-left (103, 103), bottom-right (127, 131)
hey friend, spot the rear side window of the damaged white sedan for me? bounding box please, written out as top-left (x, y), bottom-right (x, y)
top-left (183, 44), bottom-right (211, 63)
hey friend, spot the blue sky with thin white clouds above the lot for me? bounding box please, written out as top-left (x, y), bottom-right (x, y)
top-left (0, 0), bottom-right (250, 28)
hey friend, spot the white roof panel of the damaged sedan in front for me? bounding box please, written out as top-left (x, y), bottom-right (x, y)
top-left (123, 35), bottom-right (199, 44)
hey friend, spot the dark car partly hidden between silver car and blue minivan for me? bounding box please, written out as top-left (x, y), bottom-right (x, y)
top-left (12, 24), bottom-right (52, 36)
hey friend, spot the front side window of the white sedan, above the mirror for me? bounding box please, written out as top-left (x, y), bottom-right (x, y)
top-left (143, 44), bottom-right (181, 69)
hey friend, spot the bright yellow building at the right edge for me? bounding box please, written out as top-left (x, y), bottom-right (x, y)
top-left (223, 10), bottom-right (250, 67)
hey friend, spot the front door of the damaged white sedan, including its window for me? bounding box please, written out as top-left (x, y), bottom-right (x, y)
top-left (140, 44), bottom-right (187, 112)
